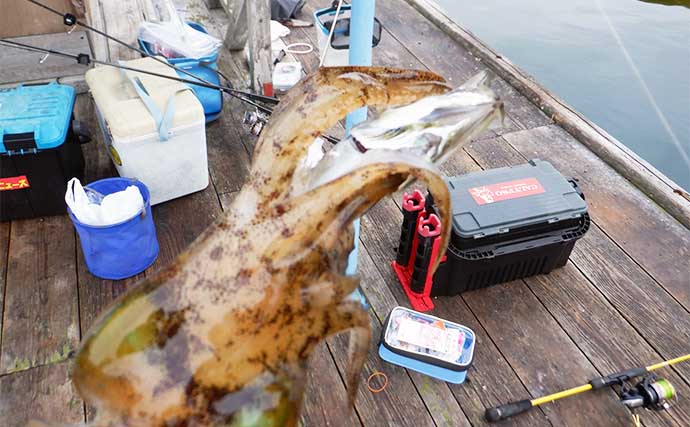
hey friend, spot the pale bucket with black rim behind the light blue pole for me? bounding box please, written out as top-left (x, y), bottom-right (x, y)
top-left (314, 4), bottom-right (382, 67)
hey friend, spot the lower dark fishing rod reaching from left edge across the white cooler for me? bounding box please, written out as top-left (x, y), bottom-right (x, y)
top-left (0, 38), bottom-right (339, 144)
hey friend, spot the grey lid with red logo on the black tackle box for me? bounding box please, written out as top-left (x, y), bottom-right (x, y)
top-left (449, 160), bottom-right (587, 239)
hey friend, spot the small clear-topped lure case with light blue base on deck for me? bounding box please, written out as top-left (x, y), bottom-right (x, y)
top-left (379, 307), bottom-right (476, 384)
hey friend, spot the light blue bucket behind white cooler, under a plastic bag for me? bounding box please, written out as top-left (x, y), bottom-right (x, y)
top-left (139, 22), bottom-right (223, 123)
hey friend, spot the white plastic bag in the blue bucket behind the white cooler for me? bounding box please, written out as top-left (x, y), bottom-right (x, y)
top-left (138, 0), bottom-right (222, 59)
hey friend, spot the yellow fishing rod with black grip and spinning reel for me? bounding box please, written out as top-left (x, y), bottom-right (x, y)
top-left (485, 354), bottom-right (690, 425)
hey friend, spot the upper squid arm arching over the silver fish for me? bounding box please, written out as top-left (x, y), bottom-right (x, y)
top-left (251, 67), bottom-right (450, 204)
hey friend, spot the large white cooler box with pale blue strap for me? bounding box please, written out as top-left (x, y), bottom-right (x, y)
top-left (86, 58), bottom-right (208, 205)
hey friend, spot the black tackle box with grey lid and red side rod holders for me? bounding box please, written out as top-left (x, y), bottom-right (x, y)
top-left (393, 160), bottom-right (590, 310)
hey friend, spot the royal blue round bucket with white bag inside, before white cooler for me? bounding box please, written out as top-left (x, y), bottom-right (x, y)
top-left (69, 178), bottom-right (158, 280)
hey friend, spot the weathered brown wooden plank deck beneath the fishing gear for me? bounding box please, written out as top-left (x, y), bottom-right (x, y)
top-left (0, 0), bottom-right (690, 427)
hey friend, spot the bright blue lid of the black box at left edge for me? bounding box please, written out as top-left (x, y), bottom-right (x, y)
top-left (0, 83), bottom-right (75, 154)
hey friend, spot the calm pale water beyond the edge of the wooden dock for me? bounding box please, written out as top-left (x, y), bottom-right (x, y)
top-left (435, 0), bottom-right (690, 189)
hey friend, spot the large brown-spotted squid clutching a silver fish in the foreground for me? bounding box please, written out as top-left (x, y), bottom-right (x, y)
top-left (51, 67), bottom-right (502, 427)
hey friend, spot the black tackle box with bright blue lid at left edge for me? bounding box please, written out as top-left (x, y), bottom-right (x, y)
top-left (0, 83), bottom-right (89, 221)
